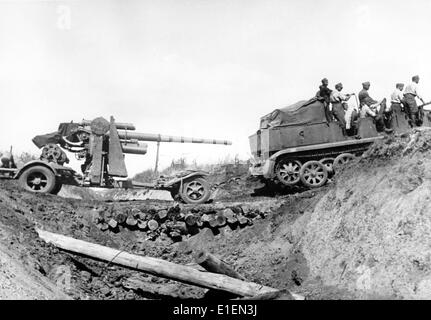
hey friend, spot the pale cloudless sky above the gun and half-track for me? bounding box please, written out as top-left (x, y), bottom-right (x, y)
top-left (0, 0), bottom-right (431, 175)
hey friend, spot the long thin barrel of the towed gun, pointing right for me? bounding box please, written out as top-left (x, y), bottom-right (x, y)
top-left (118, 130), bottom-right (232, 145)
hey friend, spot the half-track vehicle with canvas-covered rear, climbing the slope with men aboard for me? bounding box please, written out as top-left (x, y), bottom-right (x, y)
top-left (249, 98), bottom-right (431, 188)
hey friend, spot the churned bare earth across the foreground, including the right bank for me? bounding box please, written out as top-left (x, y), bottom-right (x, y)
top-left (0, 132), bottom-right (431, 299)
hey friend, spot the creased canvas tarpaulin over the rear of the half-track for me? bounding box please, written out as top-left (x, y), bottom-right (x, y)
top-left (260, 98), bottom-right (326, 129)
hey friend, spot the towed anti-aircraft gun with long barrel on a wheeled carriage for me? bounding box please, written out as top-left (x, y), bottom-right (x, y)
top-left (0, 117), bottom-right (232, 204)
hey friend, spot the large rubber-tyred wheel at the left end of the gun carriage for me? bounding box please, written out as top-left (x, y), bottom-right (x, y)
top-left (18, 166), bottom-right (55, 193)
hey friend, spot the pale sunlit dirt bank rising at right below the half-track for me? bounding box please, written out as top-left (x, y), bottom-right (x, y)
top-left (292, 131), bottom-right (431, 299)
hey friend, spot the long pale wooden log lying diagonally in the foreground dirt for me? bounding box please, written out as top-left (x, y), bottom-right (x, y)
top-left (36, 229), bottom-right (288, 297)
